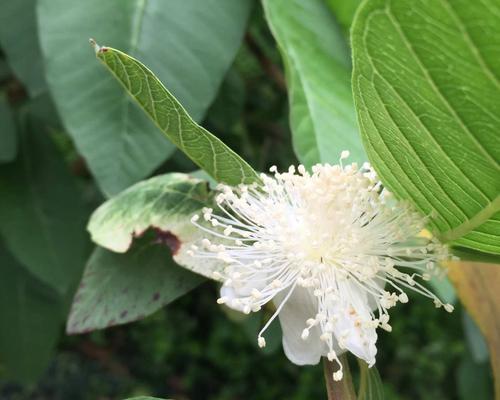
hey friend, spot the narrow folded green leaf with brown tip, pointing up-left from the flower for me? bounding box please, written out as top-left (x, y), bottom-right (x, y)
top-left (94, 44), bottom-right (258, 185)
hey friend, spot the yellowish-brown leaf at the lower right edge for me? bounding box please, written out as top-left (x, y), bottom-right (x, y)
top-left (449, 262), bottom-right (500, 398)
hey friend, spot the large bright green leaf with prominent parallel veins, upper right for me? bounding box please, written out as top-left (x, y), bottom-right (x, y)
top-left (352, 0), bottom-right (500, 254)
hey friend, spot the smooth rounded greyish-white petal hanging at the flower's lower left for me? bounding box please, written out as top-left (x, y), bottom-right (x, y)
top-left (274, 286), bottom-right (328, 365)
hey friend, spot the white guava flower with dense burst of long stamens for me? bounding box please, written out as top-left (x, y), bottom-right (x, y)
top-left (190, 152), bottom-right (453, 380)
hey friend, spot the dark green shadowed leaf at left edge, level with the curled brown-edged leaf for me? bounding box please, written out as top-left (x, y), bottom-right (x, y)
top-left (0, 118), bottom-right (88, 293)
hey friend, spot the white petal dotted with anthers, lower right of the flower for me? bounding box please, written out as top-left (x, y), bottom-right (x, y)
top-left (328, 282), bottom-right (377, 366)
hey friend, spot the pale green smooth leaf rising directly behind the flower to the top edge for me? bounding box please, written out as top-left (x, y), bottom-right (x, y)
top-left (263, 0), bottom-right (366, 167)
